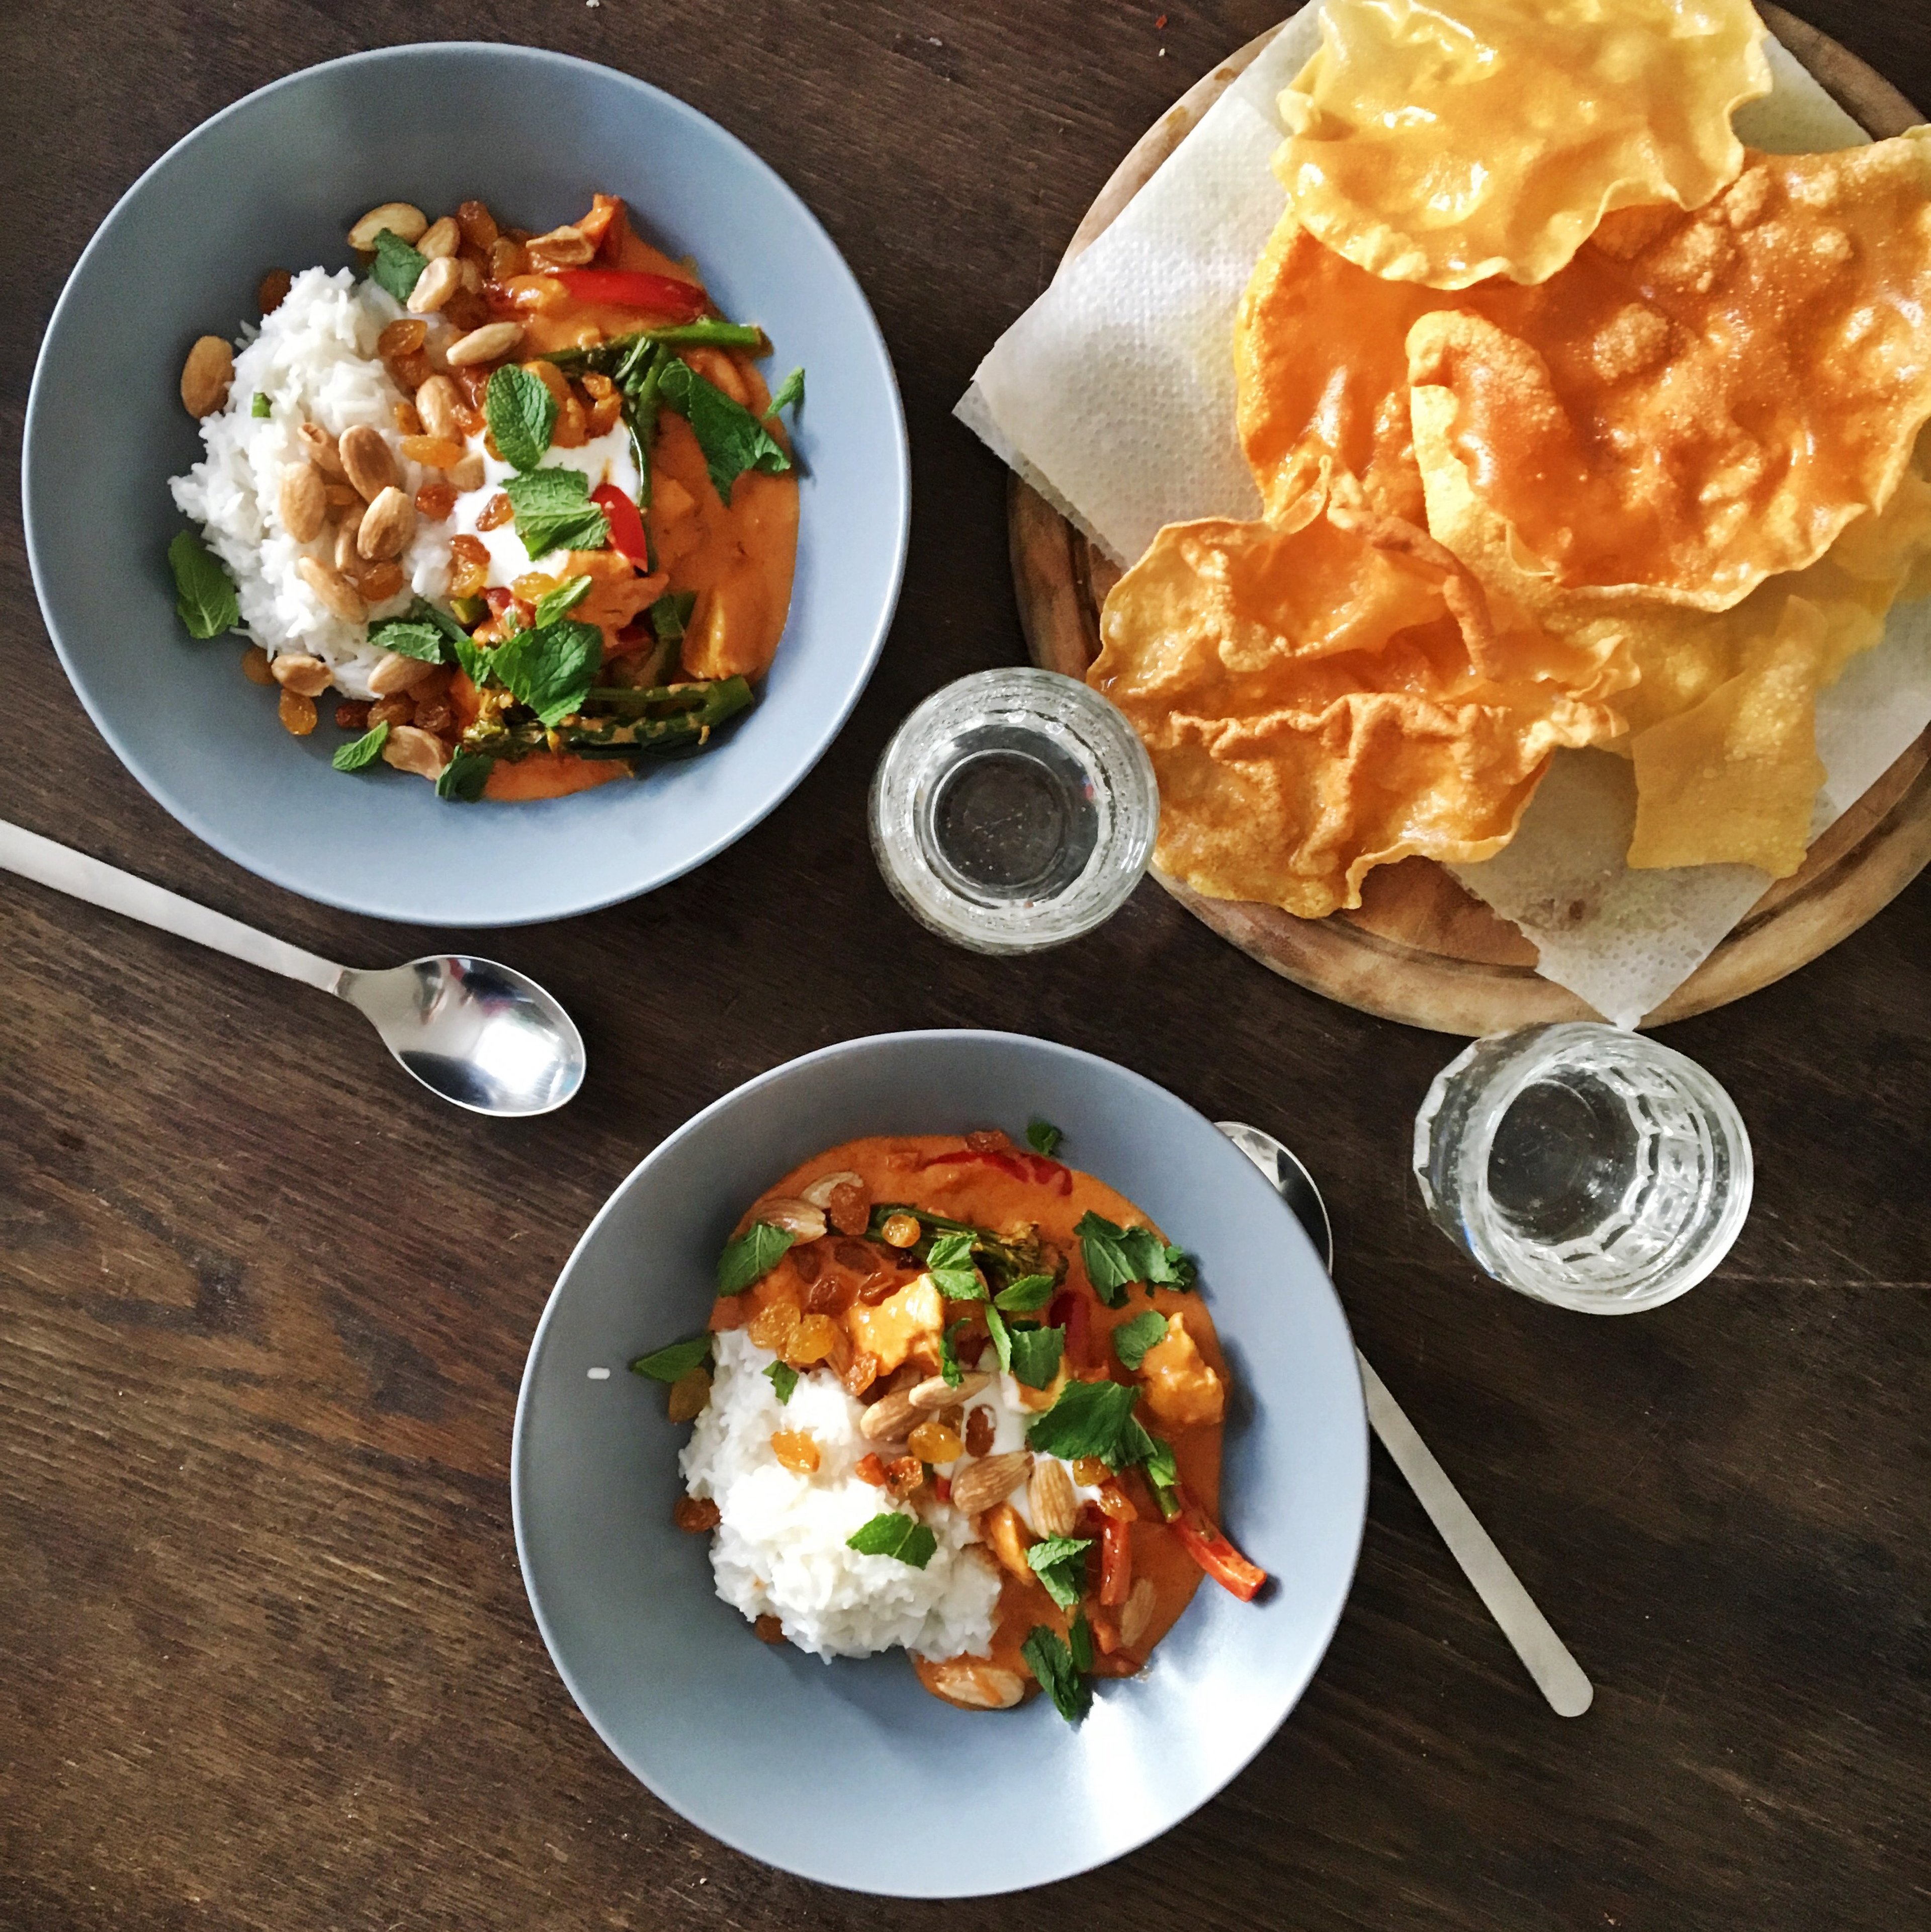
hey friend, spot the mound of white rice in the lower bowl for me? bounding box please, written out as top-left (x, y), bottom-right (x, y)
top-left (680, 1329), bottom-right (998, 1658)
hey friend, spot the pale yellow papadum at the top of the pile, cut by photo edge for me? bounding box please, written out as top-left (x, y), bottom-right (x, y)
top-left (1274, 0), bottom-right (1771, 288)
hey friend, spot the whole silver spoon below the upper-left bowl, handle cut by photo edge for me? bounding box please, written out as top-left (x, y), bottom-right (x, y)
top-left (0, 819), bottom-right (585, 1117)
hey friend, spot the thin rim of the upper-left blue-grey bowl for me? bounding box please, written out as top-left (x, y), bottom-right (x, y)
top-left (19, 41), bottom-right (911, 931)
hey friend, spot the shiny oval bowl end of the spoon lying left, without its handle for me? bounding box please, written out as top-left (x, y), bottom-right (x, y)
top-left (334, 953), bottom-right (587, 1119)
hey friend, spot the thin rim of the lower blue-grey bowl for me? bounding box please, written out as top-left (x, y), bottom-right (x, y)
top-left (510, 1026), bottom-right (1369, 1899)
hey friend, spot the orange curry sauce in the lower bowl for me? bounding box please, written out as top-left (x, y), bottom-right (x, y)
top-left (711, 1134), bottom-right (1226, 1708)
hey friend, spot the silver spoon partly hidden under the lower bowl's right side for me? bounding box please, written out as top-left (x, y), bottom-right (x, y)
top-left (1214, 1121), bottom-right (1595, 1718)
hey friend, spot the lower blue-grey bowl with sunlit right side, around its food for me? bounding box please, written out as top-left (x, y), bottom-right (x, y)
top-left (510, 1032), bottom-right (1367, 1897)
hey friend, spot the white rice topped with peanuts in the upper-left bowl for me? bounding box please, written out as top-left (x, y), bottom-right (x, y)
top-left (168, 269), bottom-right (450, 698)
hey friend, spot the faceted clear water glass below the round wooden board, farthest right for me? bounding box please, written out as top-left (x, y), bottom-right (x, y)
top-left (1416, 1022), bottom-right (1751, 1316)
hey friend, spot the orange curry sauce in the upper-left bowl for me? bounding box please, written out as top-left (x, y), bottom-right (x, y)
top-left (450, 195), bottom-right (798, 800)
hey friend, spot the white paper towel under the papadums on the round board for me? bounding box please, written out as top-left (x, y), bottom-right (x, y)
top-left (956, 4), bottom-right (1931, 1026)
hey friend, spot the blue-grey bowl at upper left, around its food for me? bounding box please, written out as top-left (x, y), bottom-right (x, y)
top-left (21, 43), bottom-right (911, 926)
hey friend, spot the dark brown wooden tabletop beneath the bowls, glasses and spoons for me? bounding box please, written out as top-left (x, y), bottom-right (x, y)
top-left (0, 0), bottom-right (1931, 1932)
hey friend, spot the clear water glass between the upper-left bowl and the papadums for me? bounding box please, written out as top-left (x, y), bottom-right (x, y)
top-left (871, 668), bottom-right (1161, 953)
